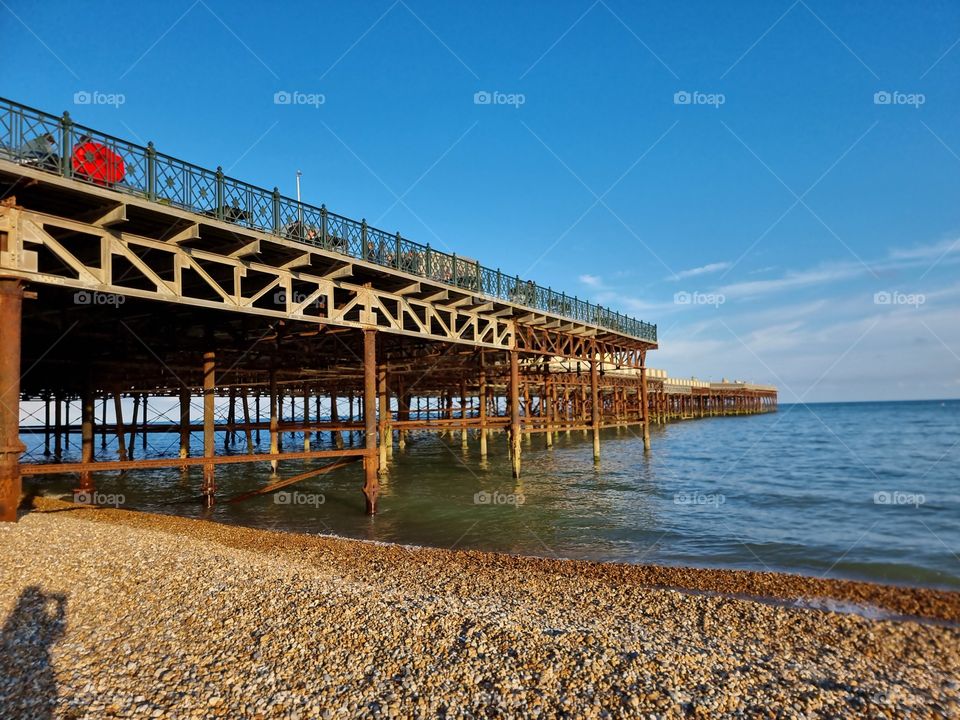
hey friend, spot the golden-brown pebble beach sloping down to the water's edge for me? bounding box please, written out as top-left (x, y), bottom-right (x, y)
top-left (0, 498), bottom-right (960, 718)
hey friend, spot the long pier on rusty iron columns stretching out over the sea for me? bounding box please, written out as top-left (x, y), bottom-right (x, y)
top-left (0, 100), bottom-right (777, 521)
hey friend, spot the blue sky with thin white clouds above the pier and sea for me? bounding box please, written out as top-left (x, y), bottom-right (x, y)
top-left (0, 0), bottom-right (960, 403)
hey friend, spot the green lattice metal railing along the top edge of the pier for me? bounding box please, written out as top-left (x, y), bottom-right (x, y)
top-left (0, 98), bottom-right (657, 342)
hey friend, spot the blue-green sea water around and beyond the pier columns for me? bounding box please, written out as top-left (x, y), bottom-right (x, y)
top-left (20, 401), bottom-right (960, 588)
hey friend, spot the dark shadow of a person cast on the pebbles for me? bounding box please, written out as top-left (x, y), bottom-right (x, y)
top-left (0, 586), bottom-right (67, 720)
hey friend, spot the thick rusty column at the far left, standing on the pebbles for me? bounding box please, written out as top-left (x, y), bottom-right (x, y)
top-left (0, 278), bottom-right (26, 522)
